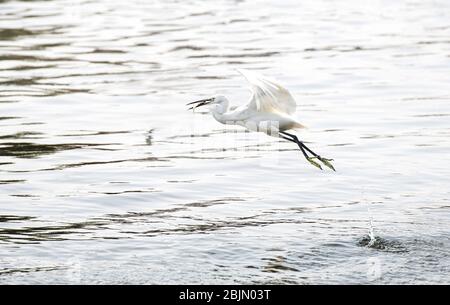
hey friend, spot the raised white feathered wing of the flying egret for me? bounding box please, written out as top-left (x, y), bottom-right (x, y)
top-left (238, 69), bottom-right (296, 114)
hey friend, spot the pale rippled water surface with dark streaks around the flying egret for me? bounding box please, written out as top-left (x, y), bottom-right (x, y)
top-left (0, 0), bottom-right (450, 284)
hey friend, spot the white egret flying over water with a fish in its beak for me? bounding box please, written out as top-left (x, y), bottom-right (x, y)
top-left (187, 69), bottom-right (335, 170)
